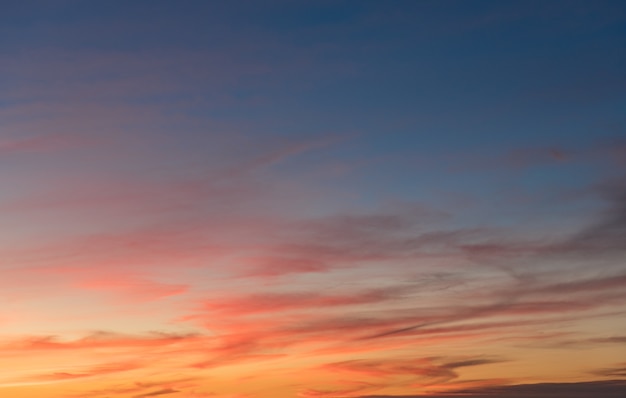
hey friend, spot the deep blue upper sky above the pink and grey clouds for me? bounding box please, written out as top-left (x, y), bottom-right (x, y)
top-left (0, 0), bottom-right (626, 213)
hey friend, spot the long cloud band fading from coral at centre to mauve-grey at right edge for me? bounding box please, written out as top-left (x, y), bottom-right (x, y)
top-left (178, 262), bottom-right (626, 367)
